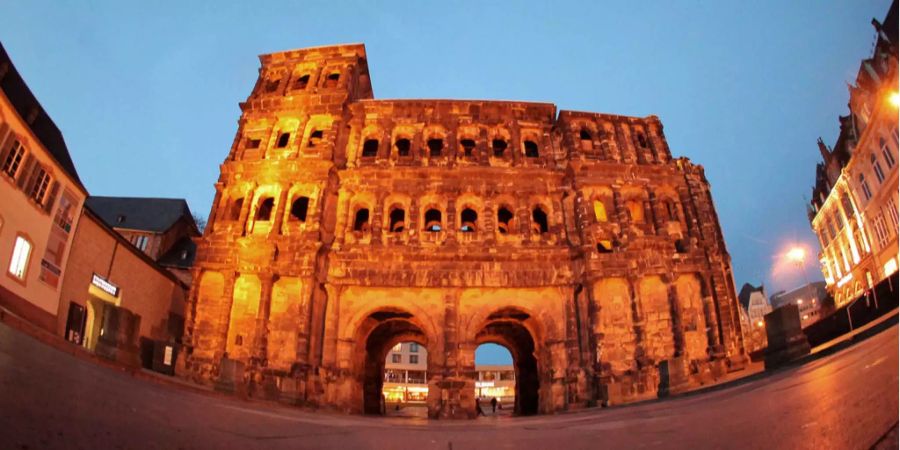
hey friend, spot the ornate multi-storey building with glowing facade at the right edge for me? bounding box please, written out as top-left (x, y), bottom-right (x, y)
top-left (809, 1), bottom-right (900, 307)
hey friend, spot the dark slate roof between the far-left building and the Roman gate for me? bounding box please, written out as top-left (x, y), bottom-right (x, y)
top-left (84, 196), bottom-right (196, 233)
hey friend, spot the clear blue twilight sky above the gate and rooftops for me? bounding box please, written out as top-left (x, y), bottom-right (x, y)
top-left (0, 0), bottom-right (890, 366)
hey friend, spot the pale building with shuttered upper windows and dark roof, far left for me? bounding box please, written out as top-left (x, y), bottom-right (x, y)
top-left (0, 45), bottom-right (87, 331)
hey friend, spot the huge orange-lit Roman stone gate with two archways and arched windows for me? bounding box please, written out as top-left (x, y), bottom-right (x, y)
top-left (179, 44), bottom-right (747, 418)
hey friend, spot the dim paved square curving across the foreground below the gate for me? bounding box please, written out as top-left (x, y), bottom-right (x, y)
top-left (0, 324), bottom-right (898, 450)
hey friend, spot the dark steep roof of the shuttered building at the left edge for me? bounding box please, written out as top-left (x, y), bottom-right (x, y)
top-left (0, 43), bottom-right (87, 192)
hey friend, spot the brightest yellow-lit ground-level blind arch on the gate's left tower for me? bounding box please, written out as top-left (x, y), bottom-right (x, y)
top-left (225, 274), bottom-right (262, 361)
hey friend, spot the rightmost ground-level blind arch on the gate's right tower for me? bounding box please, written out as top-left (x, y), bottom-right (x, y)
top-left (675, 274), bottom-right (709, 360)
